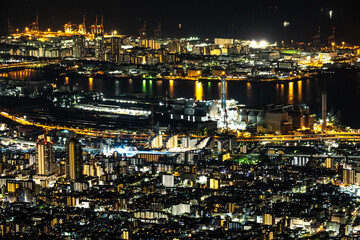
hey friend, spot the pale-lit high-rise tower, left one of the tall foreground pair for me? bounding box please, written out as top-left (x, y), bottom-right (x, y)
top-left (35, 135), bottom-right (54, 175)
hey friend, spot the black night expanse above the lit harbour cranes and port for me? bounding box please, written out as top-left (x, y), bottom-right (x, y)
top-left (0, 0), bottom-right (360, 44)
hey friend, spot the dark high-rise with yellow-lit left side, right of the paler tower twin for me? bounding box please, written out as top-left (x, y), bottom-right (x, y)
top-left (66, 138), bottom-right (82, 180)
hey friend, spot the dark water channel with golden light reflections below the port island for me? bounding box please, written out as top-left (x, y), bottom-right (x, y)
top-left (2, 70), bottom-right (360, 128)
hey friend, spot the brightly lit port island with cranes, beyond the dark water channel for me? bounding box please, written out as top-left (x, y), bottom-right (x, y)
top-left (0, 13), bottom-right (360, 75)
